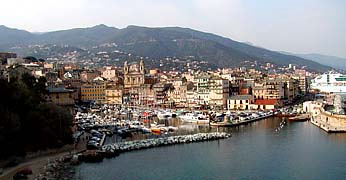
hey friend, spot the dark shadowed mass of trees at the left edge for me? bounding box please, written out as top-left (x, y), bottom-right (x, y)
top-left (0, 74), bottom-right (73, 159)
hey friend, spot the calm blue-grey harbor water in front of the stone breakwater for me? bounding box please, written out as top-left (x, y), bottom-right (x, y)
top-left (76, 118), bottom-right (346, 180)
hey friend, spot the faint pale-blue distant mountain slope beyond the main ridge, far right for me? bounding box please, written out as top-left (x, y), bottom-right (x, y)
top-left (282, 52), bottom-right (346, 70)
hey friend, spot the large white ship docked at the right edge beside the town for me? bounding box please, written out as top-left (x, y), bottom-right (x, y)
top-left (311, 72), bottom-right (346, 93)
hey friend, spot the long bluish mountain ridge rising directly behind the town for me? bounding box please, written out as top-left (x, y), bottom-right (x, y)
top-left (0, 25), bottom-right (329, 71)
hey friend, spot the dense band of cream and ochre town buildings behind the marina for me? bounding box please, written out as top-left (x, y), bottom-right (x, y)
top-left (0, 50), bottom-right (310, 110)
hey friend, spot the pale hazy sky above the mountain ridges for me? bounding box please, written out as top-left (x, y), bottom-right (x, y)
top-left (0, 0), bottom-right (346, 57)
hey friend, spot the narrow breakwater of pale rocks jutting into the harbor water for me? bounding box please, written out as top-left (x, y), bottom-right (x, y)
top-left (101, 132), bottom-right (231, 155)
